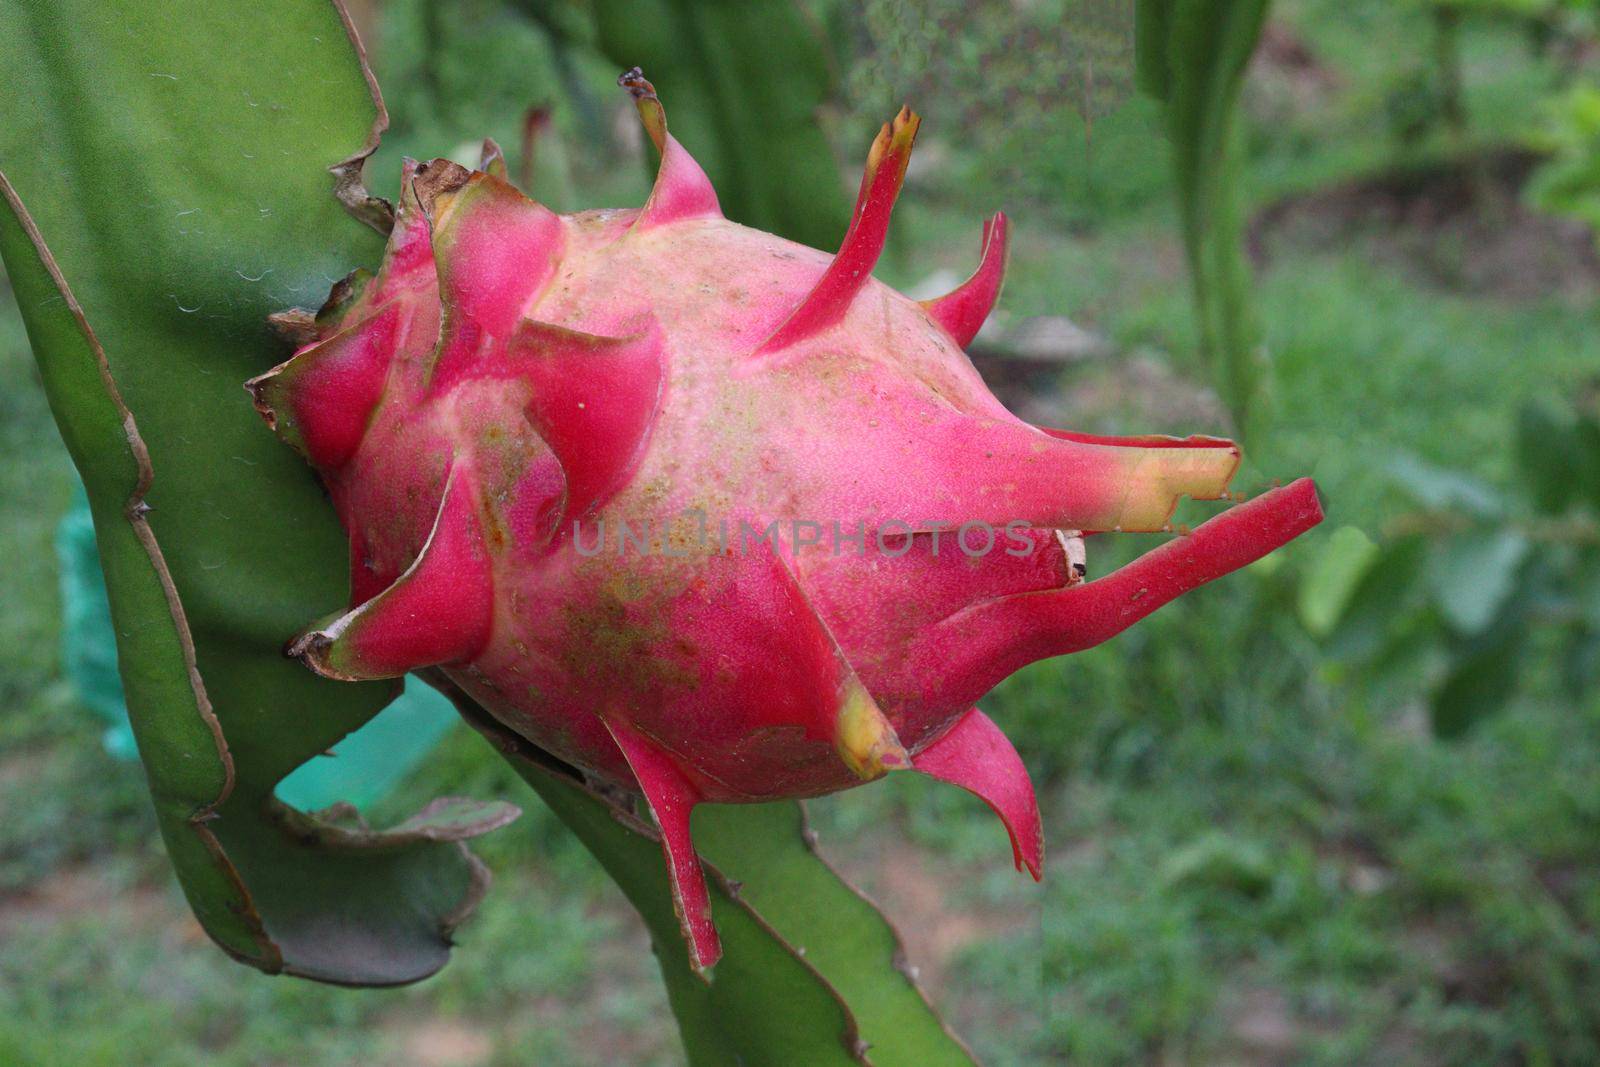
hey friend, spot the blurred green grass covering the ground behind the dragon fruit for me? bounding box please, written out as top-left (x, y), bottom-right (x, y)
top-left (0, 0), bottom-right (1600, 1065)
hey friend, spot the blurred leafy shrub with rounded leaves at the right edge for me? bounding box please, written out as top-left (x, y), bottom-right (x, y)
top-left (1299, 398), bottom-right (1600, 737)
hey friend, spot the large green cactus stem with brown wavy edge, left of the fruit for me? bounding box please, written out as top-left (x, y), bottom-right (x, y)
top-left (0, 0), bottom-right (510, 984)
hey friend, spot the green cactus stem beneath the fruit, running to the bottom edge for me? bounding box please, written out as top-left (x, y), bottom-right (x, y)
top-left (444, 694), bottom-right (974, 1067)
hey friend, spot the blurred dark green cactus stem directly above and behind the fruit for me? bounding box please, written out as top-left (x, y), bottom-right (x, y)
top-left (576, 0), bottom-right (851, 250)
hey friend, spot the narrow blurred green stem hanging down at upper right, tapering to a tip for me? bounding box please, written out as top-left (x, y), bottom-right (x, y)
top-left (1134, 0), bottom-right (1270, 437)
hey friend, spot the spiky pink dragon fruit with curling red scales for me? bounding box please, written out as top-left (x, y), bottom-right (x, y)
top-left (248, 70), bottom-right (1322, 969)
